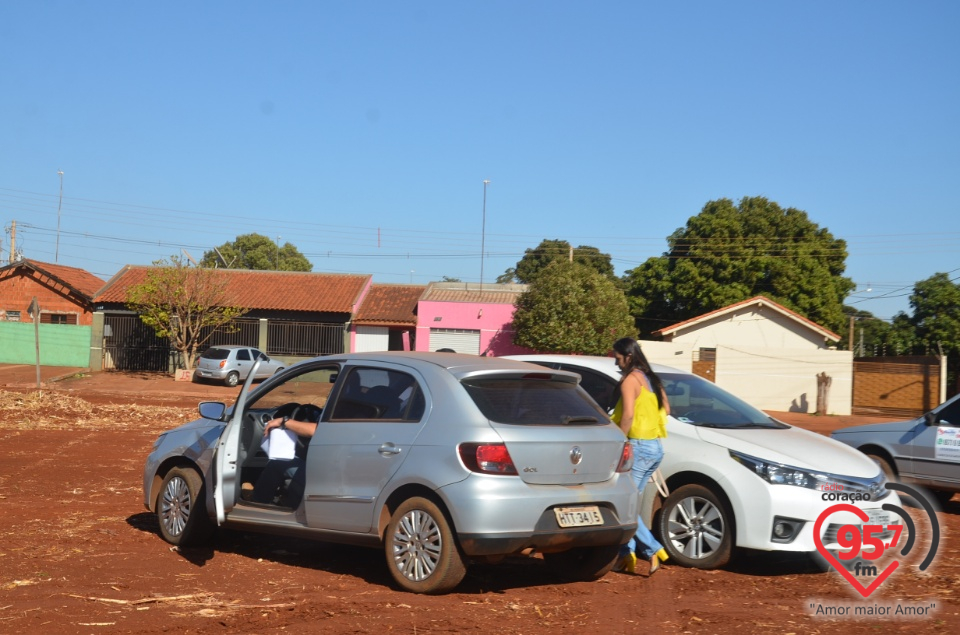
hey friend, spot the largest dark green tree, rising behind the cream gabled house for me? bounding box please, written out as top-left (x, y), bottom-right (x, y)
top-left (624, 197), bottom-right (855, 332)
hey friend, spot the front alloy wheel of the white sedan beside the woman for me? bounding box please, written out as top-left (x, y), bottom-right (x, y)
top-left (660, 484), bottom-right (733, 569)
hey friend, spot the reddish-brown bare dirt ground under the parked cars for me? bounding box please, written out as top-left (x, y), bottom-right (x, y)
top-left (0, 367), bottom-right (960, 635)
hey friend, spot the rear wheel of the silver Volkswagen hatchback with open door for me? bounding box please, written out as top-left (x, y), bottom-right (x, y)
top-left (384, 497), bottom-right (467, 595)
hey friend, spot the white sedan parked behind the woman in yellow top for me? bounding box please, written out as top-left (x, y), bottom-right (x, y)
top-left (508, 355), bottom-right (900, 569)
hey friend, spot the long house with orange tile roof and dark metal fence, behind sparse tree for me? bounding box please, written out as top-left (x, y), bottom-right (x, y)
top-left (94, 265), bottom-right (372, 370)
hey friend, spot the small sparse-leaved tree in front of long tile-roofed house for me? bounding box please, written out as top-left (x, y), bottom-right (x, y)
top-left (127, 256), bottom-right (246, 368)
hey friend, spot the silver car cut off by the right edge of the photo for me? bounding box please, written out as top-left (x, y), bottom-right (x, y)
top-left (830, 395), bottom-right (960, 504)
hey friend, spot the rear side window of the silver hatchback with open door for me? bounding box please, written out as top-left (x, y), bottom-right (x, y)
top-left (330, 366), bottom-right (426, 421)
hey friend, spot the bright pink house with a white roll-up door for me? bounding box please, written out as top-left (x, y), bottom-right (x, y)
top-left (416, 282), bottom-right (531, 356)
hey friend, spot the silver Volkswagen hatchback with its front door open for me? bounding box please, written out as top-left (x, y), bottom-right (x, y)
top-left (143, 352), bottom-right (638, 593)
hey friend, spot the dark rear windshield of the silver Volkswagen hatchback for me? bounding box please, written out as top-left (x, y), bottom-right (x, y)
top-left (463, 374), bottom-right (610, 425)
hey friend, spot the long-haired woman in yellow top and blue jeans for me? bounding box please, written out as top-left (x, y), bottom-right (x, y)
top-left (612, 337), bottom-right (670, 575)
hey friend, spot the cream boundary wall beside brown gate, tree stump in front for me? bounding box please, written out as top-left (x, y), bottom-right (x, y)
top-left (715, 346), bottom-right (853, 415)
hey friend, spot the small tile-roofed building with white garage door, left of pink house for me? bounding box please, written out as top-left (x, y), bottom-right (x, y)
top-left (350, 284), bottom-right (427, 353)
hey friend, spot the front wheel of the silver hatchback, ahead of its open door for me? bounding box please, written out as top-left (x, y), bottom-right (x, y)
top-left (157, 467), bottom-right (213, 547)
